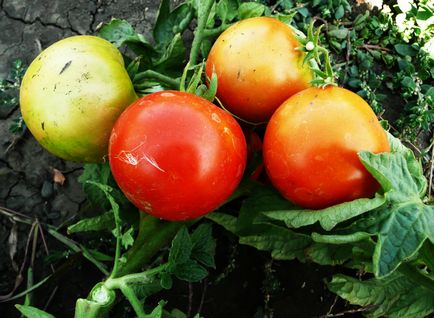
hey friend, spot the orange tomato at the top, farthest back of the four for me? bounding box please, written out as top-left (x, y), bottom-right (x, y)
top-left (206, 17), bottom-right (312, 122)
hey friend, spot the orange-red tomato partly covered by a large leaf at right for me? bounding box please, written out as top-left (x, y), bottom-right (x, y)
top-left (263, 87), bottom-right (390, 209)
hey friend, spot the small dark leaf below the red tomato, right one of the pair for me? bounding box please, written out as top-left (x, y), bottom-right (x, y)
top-left (191, 224), bottom-right (216, 268)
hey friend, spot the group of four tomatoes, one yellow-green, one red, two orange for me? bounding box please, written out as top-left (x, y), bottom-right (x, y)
top-left (20, 17), bottom-right (389, 220)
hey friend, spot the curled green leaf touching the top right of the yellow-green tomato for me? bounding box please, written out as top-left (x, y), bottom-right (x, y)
top-left (96, 19), bottom-right (154, 55)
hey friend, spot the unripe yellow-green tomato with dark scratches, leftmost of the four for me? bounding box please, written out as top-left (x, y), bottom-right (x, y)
top-left (20, 36), bottom-right (137, 162)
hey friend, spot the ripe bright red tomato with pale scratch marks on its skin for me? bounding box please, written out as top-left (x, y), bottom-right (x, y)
top-left (109, 91), bottom-right (247, 221)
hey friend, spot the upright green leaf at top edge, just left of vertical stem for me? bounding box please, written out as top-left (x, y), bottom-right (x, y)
top-left (153, 0), bottom-right (193, 44)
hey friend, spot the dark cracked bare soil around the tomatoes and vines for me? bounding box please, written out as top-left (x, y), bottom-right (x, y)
top-left (0, 0), bottom-right (372, 318)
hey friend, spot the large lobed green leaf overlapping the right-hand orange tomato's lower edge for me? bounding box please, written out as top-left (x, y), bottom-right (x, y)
top-left (355, 136), bottom-right (434, 277)
